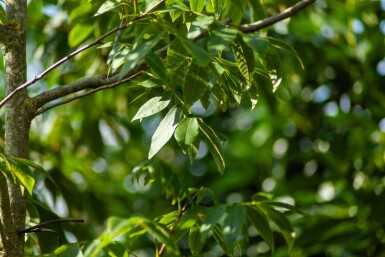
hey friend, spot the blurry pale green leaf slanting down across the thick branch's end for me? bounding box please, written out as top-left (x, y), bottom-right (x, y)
top-left (119, 32), bottom-right (164, 78)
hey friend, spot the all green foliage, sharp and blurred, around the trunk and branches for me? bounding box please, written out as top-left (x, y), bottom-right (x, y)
top-left (0, 0), bottom-right (385, 257)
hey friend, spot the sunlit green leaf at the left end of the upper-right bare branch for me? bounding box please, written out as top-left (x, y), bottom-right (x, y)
top-left (207, 27), bottom-right (238, 57)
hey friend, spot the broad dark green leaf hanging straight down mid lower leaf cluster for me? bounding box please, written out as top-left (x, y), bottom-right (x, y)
top-left (223, 204), bottom-right (245, 252)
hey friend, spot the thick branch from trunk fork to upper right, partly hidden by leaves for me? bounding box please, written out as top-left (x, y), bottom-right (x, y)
top-left (29, 0), bottom-right (316, 116)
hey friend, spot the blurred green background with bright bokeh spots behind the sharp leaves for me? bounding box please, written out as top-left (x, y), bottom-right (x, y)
top-left (0, 0), bottom-right (385, 257)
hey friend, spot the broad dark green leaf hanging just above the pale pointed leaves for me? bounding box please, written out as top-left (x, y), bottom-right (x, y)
top-left (183, 62), bottom-right (209, 106)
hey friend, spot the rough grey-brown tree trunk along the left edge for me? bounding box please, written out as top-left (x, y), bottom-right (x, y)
top-left (0, 0), bottom-right (32, 257)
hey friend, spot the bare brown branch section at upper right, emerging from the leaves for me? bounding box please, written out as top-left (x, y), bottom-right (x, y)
top-left (237, 0), bottom-right (317, 33)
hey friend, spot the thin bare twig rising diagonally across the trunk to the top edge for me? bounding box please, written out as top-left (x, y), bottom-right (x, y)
top-left (0, 0), bottom-right (165, 108)
